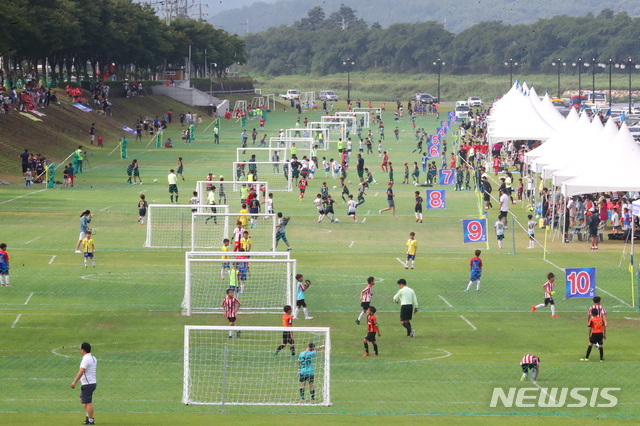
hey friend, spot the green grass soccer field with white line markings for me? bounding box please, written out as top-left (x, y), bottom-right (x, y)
top-left (0, 103), bottom-right (640, 424)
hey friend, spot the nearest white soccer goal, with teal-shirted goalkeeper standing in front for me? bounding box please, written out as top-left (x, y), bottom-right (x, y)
top-left (182, 326), bottom-right (331, 407)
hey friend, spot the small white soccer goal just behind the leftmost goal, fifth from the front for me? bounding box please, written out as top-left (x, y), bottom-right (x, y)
top-left (196, 179), bottom-right (269, 213)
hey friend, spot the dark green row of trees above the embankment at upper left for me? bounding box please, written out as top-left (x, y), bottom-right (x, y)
top-left (0, 0), bottom-right (245, 81)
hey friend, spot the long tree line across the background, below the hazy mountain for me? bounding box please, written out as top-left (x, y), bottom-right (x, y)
top-left (245, 5), bottom-right (640, 75)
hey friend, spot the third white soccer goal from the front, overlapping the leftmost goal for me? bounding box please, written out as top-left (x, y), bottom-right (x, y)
top-left (189, 213), bottom-right (277, 251)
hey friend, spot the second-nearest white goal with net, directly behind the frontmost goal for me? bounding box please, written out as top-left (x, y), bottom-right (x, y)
top-left (182, 251), bottom-right (296, 315)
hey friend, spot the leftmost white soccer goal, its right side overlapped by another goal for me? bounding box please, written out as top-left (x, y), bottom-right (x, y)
top-left (144, 204), bottom-right (229, 250)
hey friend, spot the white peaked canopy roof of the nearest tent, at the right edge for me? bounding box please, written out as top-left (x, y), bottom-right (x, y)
top-left (562, 123), bottom-right (640, 196)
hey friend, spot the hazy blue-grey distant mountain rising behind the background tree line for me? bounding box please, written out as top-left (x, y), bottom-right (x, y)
top-left (210, 0), bottom-right (640, 34)
